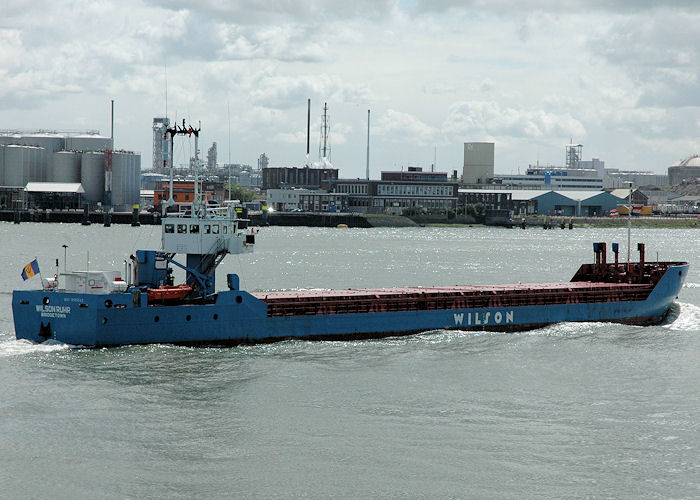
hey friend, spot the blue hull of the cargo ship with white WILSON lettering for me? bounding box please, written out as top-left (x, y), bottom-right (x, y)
top-left (12, 263), bottom-right (688, 347)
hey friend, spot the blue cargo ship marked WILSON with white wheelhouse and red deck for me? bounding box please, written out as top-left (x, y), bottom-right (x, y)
top-left (12, 207), bottom-right (688, 347)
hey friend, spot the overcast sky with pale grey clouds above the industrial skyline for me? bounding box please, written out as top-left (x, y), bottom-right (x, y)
top-left (0, 0), bottom-right (700, 178)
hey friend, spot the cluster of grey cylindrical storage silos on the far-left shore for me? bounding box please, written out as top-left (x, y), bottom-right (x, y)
top-left (0, 131), bottom-right (141, 211)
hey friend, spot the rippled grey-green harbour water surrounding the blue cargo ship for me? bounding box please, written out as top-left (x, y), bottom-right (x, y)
top-left (0, 223), bottom-right (700, 498)
